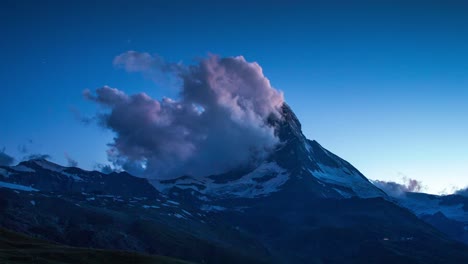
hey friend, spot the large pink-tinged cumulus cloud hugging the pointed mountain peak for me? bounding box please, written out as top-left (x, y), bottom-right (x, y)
top-left (84, 51), bottom-right (284, 178)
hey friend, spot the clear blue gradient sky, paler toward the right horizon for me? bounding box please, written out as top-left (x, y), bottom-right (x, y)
top-left (0, 1), bottom-right (468, 193)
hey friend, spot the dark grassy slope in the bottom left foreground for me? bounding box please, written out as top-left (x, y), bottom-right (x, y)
top-left (0, 228), bottom-right (188, 264)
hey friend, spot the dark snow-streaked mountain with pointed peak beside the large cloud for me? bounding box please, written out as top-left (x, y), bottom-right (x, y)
top-left (0, 105), bottom-right (468, 263)
